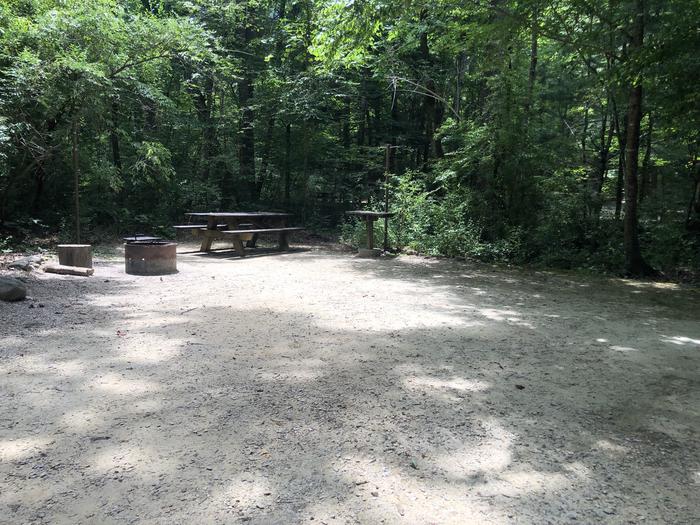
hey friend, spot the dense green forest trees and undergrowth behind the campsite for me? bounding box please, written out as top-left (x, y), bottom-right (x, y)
top-left (0, 0), bottom-right (700, 274)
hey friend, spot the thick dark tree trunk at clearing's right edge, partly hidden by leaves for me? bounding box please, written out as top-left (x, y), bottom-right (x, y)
top-left (624, 0), bottom-right (653, 276)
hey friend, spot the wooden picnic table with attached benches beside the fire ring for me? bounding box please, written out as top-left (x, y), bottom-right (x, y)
top-left (175, 211), bottom-right (303, 256)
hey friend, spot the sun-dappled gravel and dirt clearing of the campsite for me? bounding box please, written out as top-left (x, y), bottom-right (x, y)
top-left (0, 244), bottom-right (700, 524)
